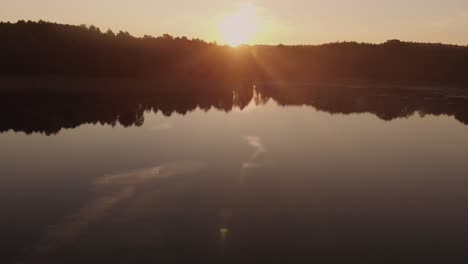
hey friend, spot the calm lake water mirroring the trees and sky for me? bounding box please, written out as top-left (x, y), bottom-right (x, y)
top-left (0, 81), bottom-right (468, 263)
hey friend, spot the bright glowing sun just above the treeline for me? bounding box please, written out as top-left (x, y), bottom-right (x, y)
top-left (220, 4), bottom-right (258, 47)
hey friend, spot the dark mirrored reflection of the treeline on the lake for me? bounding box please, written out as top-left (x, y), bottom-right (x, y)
top-left (0, 81), bottom-right (468, 135)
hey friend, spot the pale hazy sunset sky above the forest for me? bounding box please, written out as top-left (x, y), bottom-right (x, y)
top-left (0, 0), bottom-right (468, 45)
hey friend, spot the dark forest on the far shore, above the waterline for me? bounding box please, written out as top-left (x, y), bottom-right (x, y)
top-left (0, 21), bottom-right (468, 85)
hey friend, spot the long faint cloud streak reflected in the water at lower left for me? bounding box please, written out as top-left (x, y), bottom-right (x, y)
top-left (30, 163), bottom-right (202, 255)
